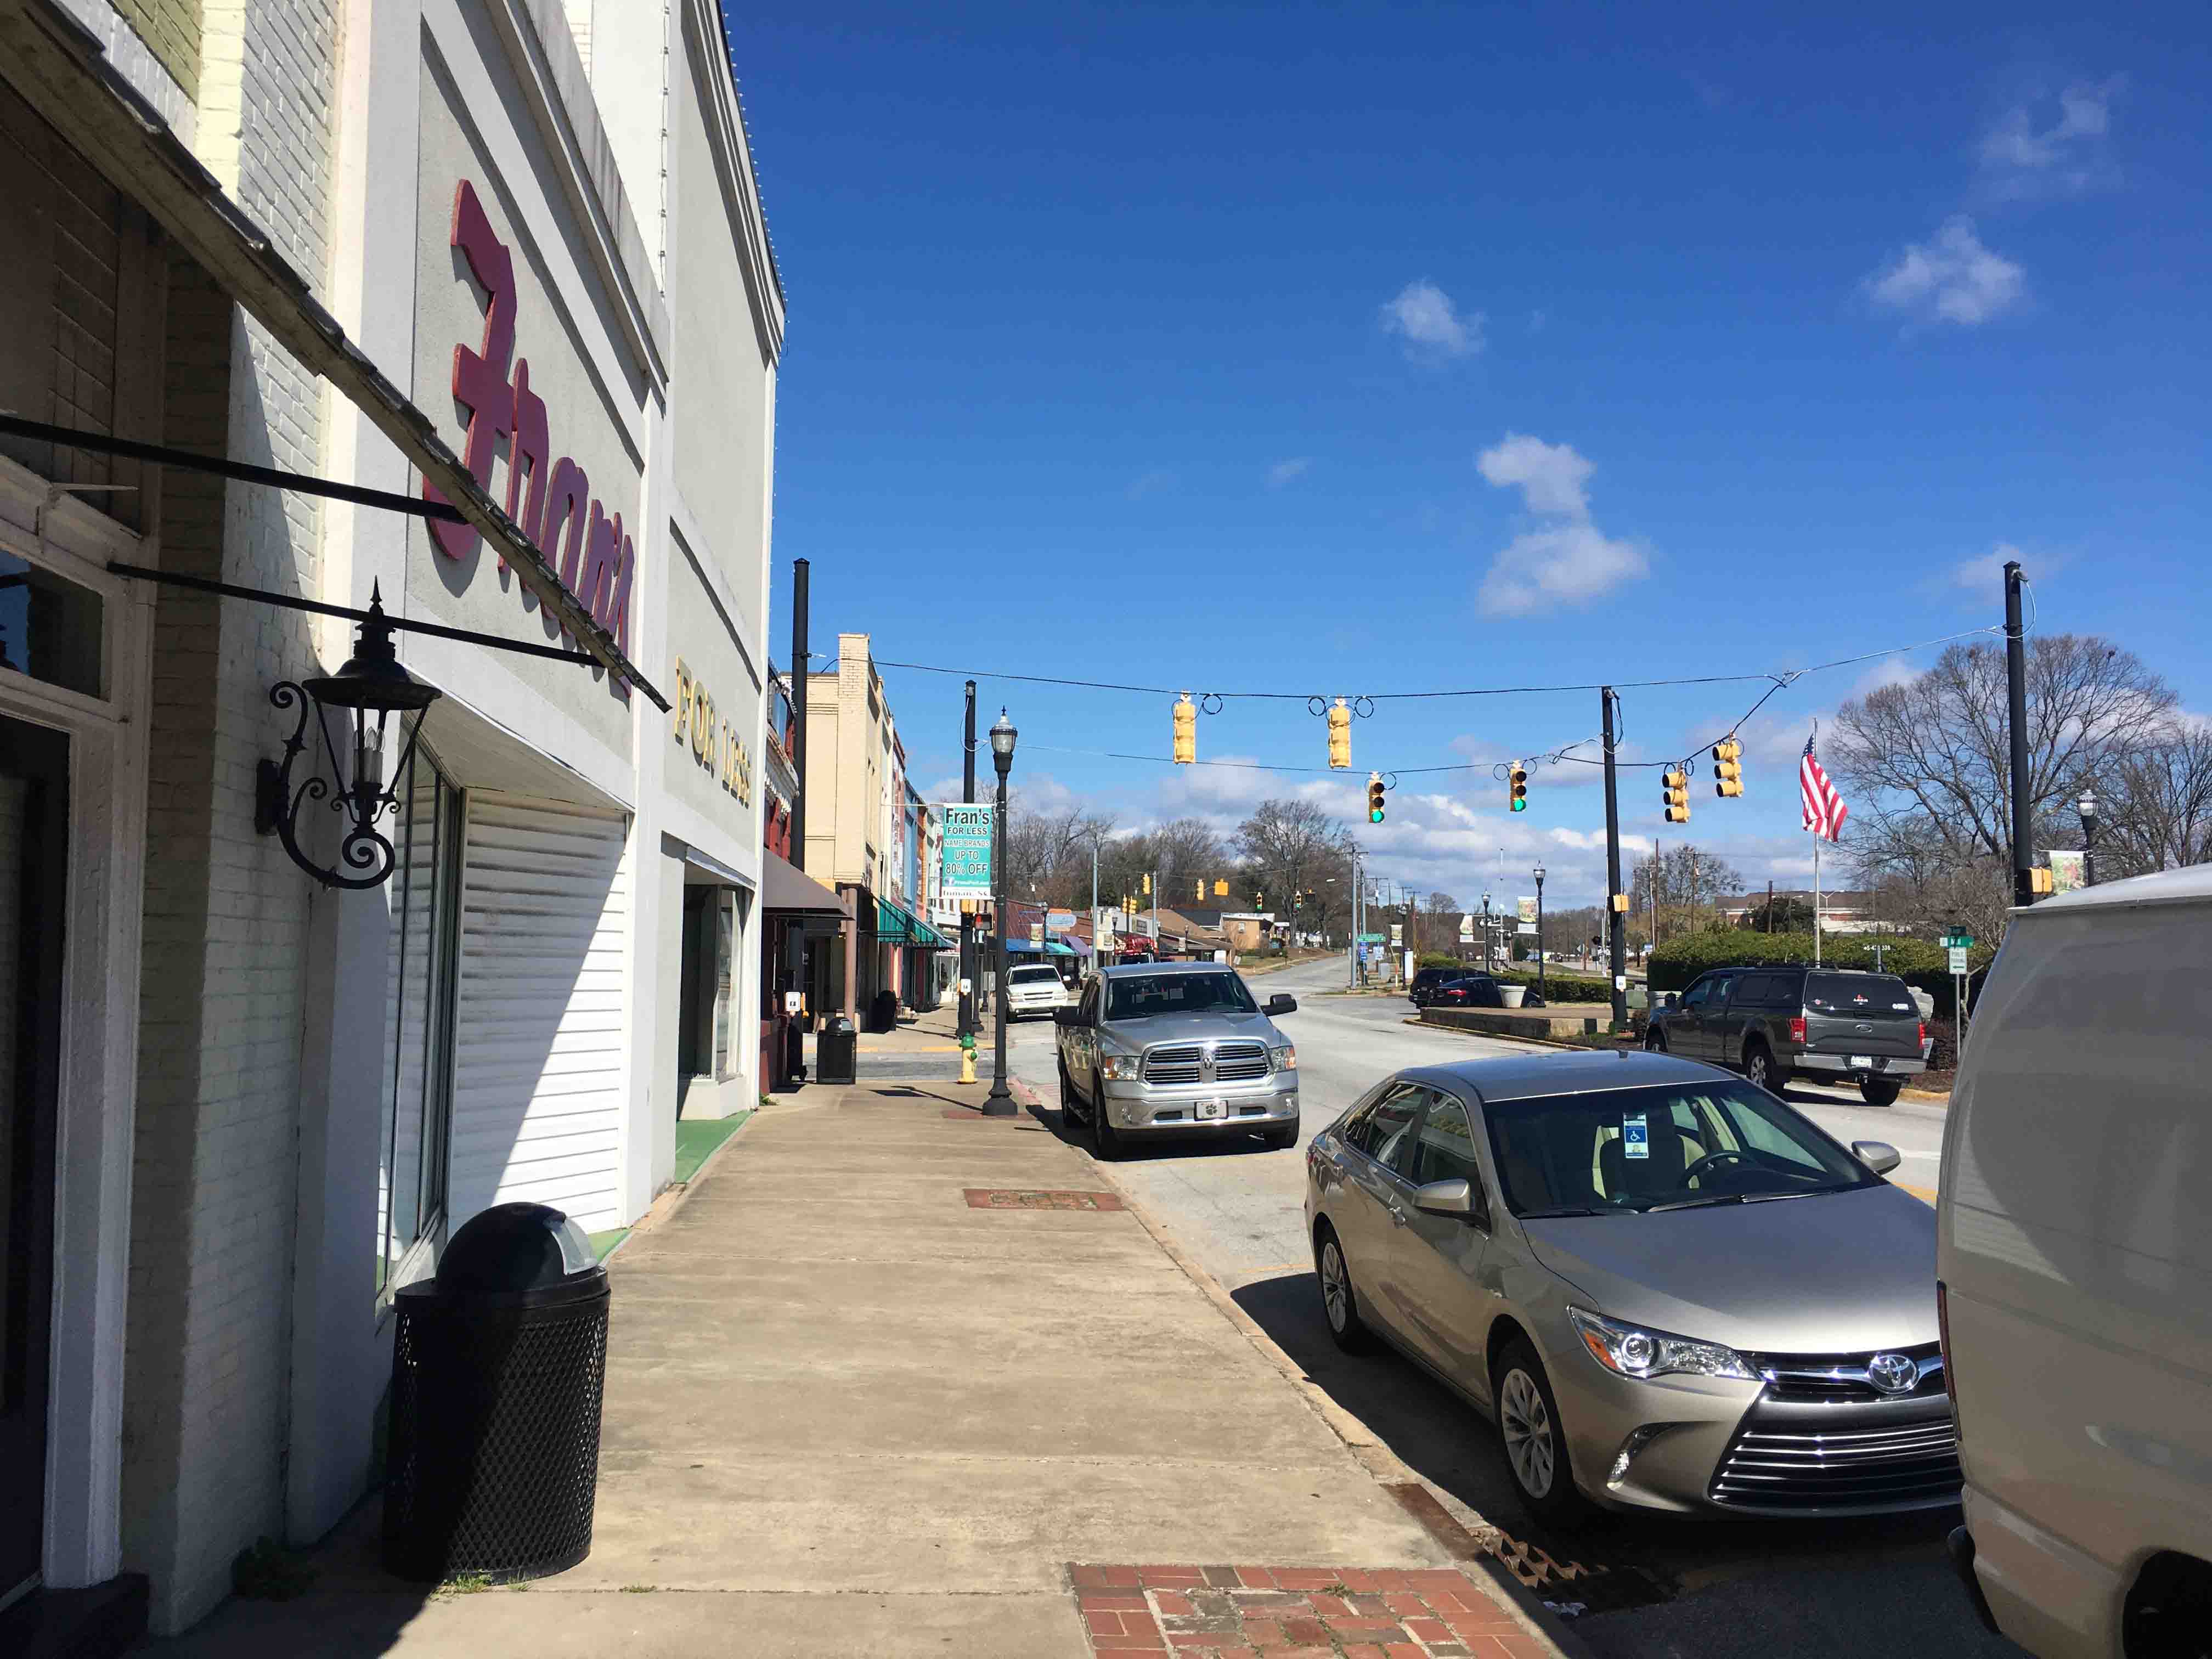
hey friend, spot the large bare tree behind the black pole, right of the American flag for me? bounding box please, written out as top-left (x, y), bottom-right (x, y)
top-left (1825, 635), bottom-right (2176, 938)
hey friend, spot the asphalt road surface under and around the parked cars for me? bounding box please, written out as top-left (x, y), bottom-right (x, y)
top-left (1011, 962), bottom-right (2019, 1659)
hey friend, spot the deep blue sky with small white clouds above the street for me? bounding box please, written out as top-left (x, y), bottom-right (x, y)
top-left (730, 4), bottom-right (2212, 902)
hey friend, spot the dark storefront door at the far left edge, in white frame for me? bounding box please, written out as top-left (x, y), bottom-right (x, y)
top-left (0, 716), bottom-right (69, 1606)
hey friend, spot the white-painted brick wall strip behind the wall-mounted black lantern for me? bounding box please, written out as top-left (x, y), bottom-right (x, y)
top-left (124, 0), bottom-right (340, 1630)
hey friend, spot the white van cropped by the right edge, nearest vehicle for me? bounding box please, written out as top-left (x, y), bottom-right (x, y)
top-left (1936, 865), bottom-right (2212, 1659)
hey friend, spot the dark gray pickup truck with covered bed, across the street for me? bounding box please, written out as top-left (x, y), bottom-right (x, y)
top-left (1644, 967), bottom-right (1929, 1106)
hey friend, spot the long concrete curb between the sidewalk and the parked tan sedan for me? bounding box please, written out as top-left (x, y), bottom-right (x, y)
top-left (1092, 1159), bottom-right (1590, 1659)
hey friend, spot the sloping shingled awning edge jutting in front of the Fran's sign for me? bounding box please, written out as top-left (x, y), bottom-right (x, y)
top-left (0, 0), bottom-right (668, 710)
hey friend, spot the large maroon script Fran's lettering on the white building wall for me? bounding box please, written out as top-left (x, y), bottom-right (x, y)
top-left (422, 179), bottom-right (637, 663)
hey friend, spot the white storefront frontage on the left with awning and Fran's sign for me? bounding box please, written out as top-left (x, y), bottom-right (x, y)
top-left (0, 0), bottom-right (783, 1630)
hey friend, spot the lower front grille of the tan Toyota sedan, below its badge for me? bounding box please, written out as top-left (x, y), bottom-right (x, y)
top-left (1710, 1415), bottom-right (1960, 1509)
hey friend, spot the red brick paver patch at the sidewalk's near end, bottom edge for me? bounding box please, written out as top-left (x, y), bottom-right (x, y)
top-left (1068, 1562), bottom-right (1553, 1659)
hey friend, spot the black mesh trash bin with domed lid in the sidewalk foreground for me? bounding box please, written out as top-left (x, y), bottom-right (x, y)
top-left (385, 1203), bottom-right (608, 1584)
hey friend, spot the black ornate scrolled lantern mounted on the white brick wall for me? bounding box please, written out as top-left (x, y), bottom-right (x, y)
top-left (255, 589), bottom-right (440, 889)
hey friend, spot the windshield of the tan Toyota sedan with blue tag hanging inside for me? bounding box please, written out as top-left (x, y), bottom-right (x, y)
top-left (1482, 1080), bottom-right (1880, 1217)
